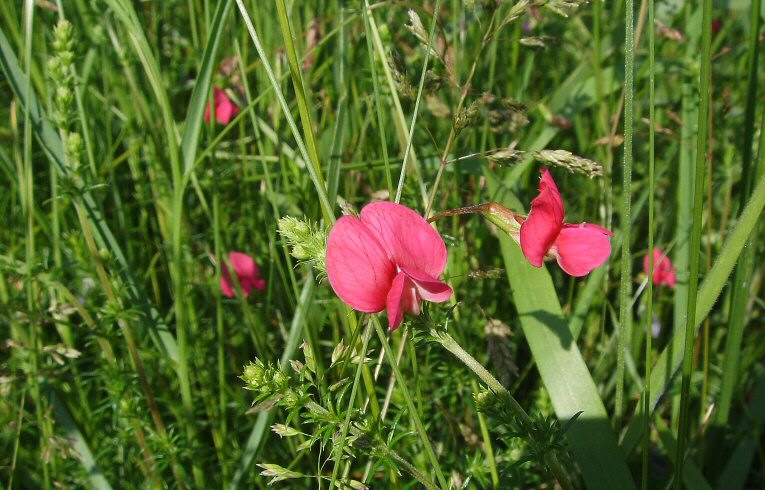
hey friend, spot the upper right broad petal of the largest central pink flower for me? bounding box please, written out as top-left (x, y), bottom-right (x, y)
top-left (361, 201), bottom-right (446, 277)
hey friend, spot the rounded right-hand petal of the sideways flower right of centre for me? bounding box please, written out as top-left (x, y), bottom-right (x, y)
top-left (555, 223), bottom-right (611, 277)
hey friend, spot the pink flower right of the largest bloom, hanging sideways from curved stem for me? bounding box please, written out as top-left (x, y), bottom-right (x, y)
top-left (520, 168), bottom-right (614, 277)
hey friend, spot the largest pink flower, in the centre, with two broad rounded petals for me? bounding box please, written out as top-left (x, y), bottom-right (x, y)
top-left (327, 202), bottom-right (452, 330)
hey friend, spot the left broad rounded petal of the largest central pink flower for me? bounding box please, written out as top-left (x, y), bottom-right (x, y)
top-left (327, 216), bottom-right (396, 313)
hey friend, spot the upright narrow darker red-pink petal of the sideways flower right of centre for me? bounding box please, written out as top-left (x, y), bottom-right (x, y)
top-left (521, 168), bottom-right (563, 267)
